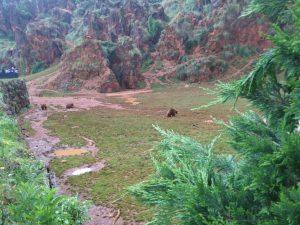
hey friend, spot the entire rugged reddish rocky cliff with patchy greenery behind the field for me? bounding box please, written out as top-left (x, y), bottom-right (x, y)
top-left (0, 0), bottom-right (270, 92)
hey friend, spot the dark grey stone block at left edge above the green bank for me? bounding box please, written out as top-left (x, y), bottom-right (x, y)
top-left (0, 80), bottom-right (30, 115)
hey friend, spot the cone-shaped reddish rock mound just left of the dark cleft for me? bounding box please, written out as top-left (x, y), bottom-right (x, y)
top-left (48, 39), bottom-right (120, 92)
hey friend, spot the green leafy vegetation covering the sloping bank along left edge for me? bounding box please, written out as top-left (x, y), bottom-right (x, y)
top-left (0, 94), bottom-right (87, 225)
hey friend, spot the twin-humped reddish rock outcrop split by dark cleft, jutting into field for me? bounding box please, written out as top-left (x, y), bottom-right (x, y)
top-left (48, 38), bottom-right (143, 92)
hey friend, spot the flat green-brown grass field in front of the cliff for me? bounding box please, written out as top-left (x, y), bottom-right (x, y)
top-left (45, 85), bottom-right (250, 220)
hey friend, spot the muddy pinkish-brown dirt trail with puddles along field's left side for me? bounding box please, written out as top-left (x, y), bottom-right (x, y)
top-left (24, 74), bottom-right (146, 225)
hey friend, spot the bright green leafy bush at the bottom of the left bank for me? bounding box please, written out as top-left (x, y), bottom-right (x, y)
top-left (9, 183), bottom-right (87, 225)
